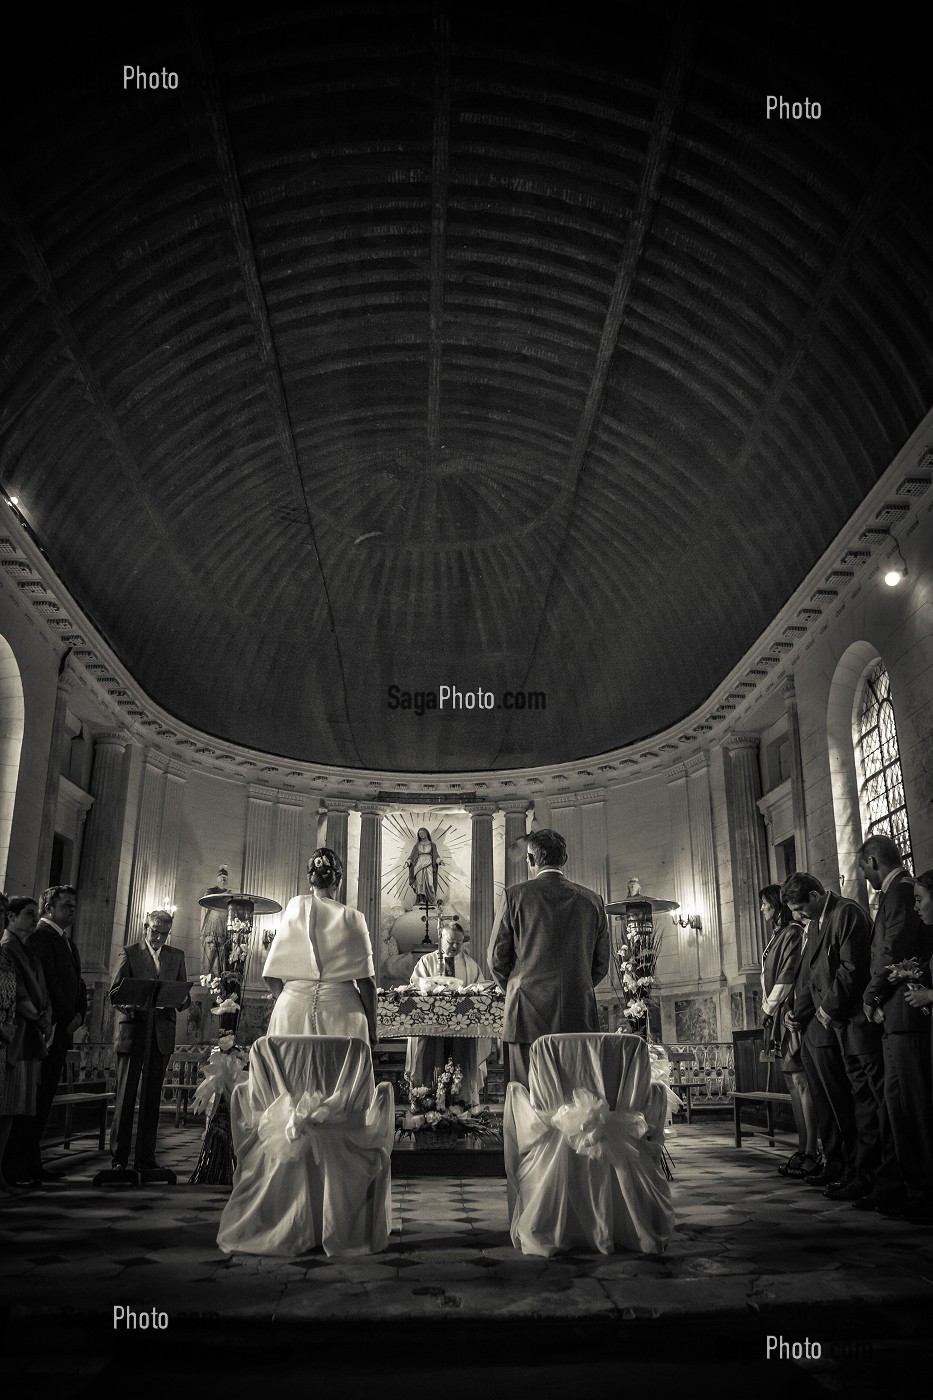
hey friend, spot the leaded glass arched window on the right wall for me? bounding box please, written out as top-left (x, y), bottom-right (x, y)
top-left (855, 661), bottom-right (911, 868)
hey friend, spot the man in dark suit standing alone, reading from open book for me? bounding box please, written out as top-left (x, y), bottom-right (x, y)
top-left (111, 909), bottom-right (191, 1170)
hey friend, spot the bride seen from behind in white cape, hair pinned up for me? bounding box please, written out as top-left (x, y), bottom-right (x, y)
top-left (262, 846), bottom-right (377, 1046)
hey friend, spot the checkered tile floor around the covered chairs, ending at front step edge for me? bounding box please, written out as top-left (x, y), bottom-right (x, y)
top-left (0, 1116), bottom-right (933, 1326)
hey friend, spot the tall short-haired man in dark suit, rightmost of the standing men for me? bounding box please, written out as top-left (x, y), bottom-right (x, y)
top-left (859, 836), bottom-right (933, 1215)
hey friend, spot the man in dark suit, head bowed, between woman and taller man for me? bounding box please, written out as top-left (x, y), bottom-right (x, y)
top-left (782, 872), bottom-right (892, 1201)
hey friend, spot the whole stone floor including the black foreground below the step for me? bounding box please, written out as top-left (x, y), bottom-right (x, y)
top-left (0, 1117), bottom-right (933, 1400)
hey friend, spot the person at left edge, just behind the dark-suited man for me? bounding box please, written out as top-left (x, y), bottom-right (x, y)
top-left (0, 895), bottom-right (52, 1193)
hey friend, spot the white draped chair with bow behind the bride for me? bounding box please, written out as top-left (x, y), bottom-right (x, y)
top-left (217, 1036), bottom-right (395, 1256)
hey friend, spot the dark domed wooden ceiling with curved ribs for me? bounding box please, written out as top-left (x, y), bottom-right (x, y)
top-left (0, 4), bottom-right (933, 771)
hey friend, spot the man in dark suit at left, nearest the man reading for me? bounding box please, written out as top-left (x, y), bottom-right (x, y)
top-left (10, 885), bottom-right (87, 1184)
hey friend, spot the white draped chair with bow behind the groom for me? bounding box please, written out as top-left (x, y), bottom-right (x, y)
top-left (503, 1035), bottom-right (674, 1257)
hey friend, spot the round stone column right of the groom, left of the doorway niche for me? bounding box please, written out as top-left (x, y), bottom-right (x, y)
top-left (723, 734), bottom-right (769, 973)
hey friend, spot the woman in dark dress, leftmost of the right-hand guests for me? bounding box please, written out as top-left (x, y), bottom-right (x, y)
top-left (758, 885), bottom-right (820, 1179)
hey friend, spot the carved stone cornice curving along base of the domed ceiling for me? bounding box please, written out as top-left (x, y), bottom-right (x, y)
top-left (0, 410), bottom-right (933, 811)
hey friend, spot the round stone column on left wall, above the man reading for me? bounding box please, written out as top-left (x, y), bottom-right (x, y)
top-left (74, 729), bottom-right (127, 977)
